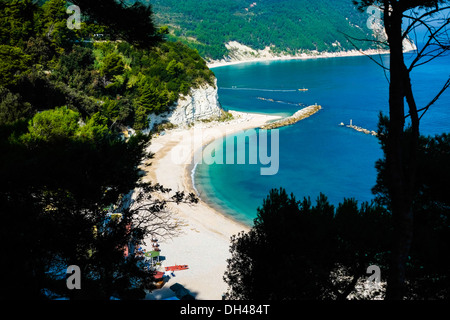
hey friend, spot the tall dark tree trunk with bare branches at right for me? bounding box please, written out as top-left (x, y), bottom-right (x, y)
top-left (353, 0), bottom-right (450, 300)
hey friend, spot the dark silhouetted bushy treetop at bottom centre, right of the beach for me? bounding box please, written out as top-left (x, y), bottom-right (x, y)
top-left (224, 189), bottom-right (391, 300)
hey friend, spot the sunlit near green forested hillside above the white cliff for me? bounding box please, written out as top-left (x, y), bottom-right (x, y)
top-left (0, 0), bottom-right (214, 129)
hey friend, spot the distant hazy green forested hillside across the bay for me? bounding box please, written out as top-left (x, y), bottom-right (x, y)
top-left (133, 0), bottom-right (372, 59)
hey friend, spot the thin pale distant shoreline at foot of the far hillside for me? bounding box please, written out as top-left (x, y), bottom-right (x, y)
top-left (206, 49), bottom-right (389, 69)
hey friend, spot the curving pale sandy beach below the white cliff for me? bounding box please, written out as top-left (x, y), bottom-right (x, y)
top-left (143, 111), bottom-right (281, 300)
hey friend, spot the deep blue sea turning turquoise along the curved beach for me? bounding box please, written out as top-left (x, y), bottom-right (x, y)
top-left (195, 55), bottom-right (450, 225)
